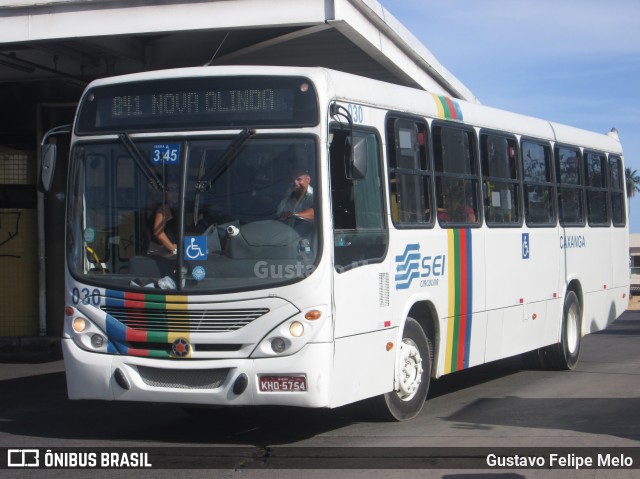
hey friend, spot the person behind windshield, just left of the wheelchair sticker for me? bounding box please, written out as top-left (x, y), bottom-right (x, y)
top-left (148, 186), bottom-right (178, 256)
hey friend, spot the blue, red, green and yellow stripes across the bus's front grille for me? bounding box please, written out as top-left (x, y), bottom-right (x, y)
top-left (105, 290), bottom-right (190, 358)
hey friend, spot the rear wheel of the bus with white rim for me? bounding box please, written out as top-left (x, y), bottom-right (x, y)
top-left (545, 291), bottom-right (582, 371)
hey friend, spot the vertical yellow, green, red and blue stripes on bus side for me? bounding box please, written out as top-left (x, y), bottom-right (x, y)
top-left (445, 229), bottom-right (473, 374)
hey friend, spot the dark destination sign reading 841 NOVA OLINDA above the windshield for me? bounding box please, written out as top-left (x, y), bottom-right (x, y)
top-left (76, 77), bottom-right (318, 134)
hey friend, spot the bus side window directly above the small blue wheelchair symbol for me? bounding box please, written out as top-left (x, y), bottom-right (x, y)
top-left (521, 140), bottom-right (556, 226)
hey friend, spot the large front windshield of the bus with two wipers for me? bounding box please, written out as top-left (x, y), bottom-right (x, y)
top-left (67, 134), bottom-right (320, 293)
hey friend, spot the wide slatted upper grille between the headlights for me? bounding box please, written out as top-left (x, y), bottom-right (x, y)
top-left (102, 306), bottom-right (269, 333)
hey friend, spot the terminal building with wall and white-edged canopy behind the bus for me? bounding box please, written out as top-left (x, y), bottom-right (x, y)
top-left (0, 0), bottom-right (477, 337)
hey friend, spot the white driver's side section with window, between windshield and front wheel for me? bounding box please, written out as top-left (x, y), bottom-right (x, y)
top-left (329, 125), bottom-right (397, 406)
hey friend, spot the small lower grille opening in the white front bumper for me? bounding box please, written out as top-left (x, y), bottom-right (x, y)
top-left (138, 366), bottom-right (229, 389)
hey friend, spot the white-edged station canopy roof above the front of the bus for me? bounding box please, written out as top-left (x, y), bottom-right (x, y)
top-left (0, 0), bottom-right (477, 101)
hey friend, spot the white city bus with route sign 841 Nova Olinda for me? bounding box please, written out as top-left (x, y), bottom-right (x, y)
top-left (43, 66), bottom-right (629, 420)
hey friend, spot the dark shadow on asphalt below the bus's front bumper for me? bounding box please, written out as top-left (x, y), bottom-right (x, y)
top-left (0, 372), bottom-right (366, 447)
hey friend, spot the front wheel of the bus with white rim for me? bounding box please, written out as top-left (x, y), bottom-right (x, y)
top-left (368, 318), bottom-right (433, 421)
